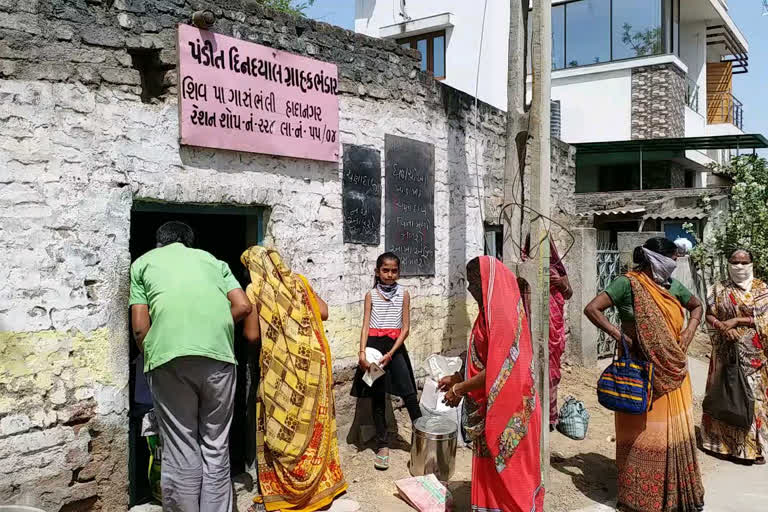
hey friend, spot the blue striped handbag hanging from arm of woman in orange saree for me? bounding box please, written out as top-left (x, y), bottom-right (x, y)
top-left (597, 335), bottom-right (653, 414)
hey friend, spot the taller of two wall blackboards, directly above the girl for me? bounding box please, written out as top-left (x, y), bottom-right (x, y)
top-left (384, 135), bottom-right (435, 276)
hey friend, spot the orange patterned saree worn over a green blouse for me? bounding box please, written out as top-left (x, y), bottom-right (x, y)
top-left (616, 272), bottom-right (704, 512)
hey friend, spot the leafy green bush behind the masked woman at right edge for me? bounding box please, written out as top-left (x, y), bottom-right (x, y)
top-left (692, 155), bottom-right (768, 278)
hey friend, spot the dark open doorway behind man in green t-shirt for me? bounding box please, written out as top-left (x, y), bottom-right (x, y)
top-left (129, 202), bottom-right (263, 505)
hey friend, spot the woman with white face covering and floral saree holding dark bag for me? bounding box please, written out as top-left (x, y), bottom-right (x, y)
top-left (701, 249), bottom-right (768, 464)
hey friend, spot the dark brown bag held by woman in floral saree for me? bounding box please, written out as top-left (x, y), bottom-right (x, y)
top-left (702, 343), bottom-right (755, 429)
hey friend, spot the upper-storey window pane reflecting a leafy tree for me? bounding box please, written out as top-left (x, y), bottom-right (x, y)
top-left (613, 0), bottom-right (664, 60)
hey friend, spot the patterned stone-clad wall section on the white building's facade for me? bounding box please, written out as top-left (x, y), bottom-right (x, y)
top-left (631, 64), bottom-right (685, 139)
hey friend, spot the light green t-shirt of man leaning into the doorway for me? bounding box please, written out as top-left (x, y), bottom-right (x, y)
top-left (130, 243), bottom-right (240, 372)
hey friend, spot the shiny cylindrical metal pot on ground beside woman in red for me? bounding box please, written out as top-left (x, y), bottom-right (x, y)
top-left (410, 416), bottom-right (459, 482)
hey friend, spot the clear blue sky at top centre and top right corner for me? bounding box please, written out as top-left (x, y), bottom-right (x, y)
top-left (307, 0), bottom-right (768, 137)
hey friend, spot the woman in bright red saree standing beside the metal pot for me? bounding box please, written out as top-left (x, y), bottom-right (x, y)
top-left (440, 256), bottom-right (544, 512)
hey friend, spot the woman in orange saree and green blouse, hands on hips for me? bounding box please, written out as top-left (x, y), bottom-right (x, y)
top-left (584, 238), bottom-right (704, 512)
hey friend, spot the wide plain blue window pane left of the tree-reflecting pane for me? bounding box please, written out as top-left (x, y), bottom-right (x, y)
top-left (565, 0), bottom-right (611, 67)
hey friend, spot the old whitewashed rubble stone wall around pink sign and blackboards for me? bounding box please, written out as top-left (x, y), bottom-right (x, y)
top-left (0, 0), bottom-right (575, 512)
